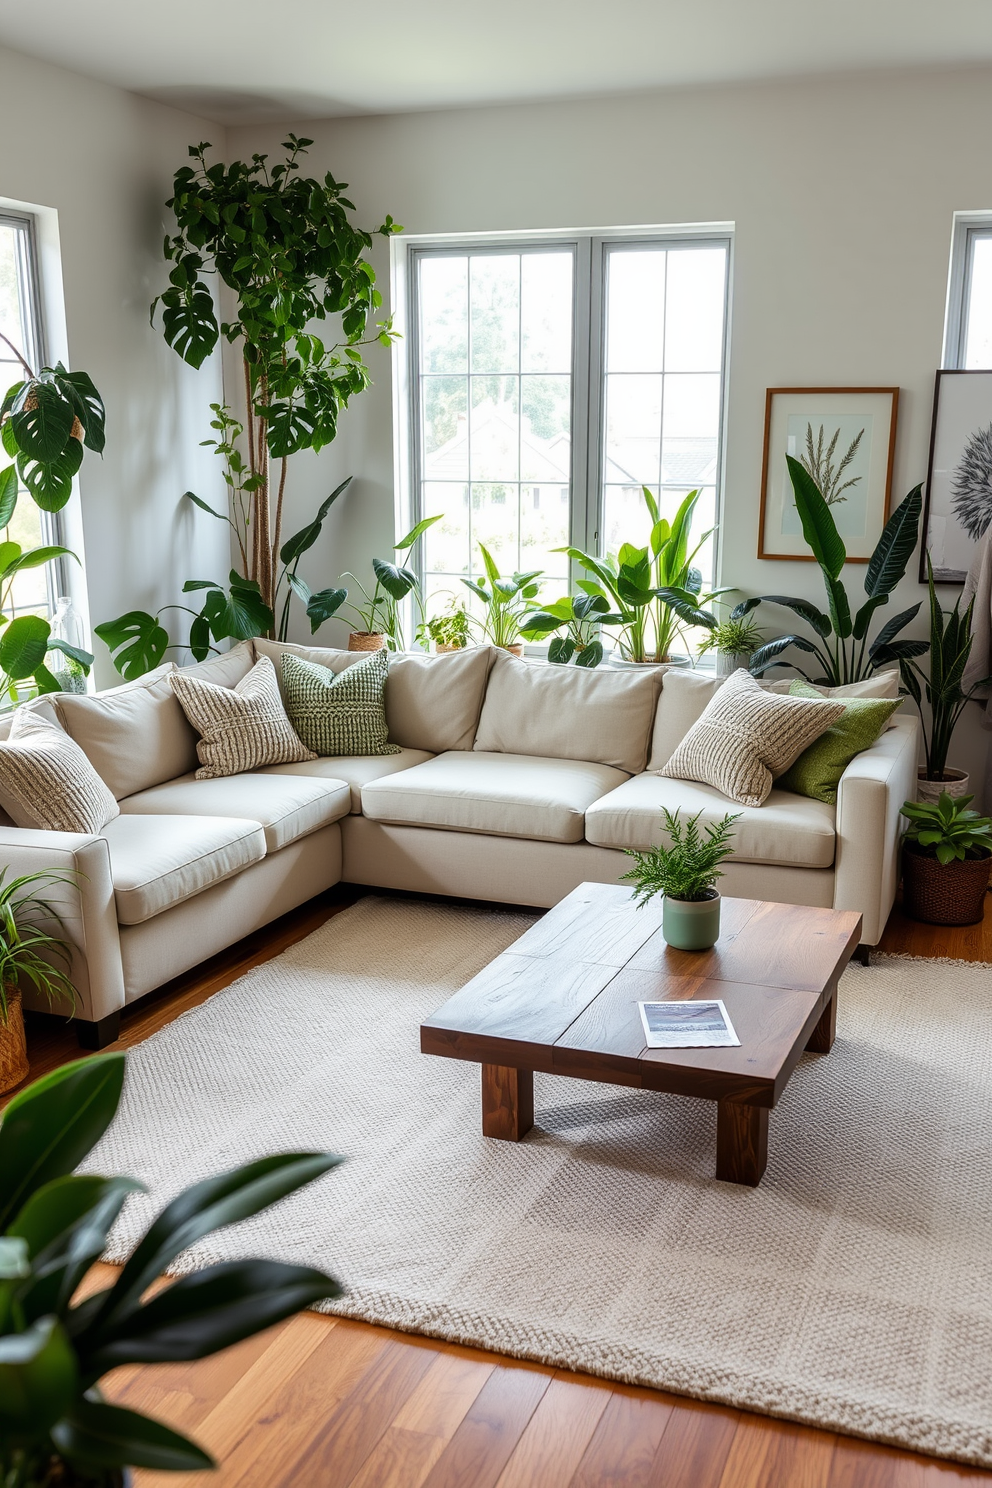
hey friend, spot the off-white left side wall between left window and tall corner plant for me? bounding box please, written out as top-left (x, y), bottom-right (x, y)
top-left (0, 49), bottom-right (229, 686)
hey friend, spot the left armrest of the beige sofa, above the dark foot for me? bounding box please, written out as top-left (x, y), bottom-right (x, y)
top-left (0, 827), bottom-right (123, 1022)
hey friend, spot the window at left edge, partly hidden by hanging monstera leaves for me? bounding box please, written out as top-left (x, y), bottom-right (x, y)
top-left (0, 213), bottom-right (64, 616)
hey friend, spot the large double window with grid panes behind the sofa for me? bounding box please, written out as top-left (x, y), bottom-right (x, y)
top-left (408, 232), bottom-right (730, 612)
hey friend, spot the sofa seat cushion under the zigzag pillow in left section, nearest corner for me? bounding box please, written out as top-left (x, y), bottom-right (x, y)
top-left (120, 774), bottom-right (351, 853)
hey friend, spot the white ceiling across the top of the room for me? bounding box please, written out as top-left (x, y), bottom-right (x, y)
top-left (0, 0), bottom-right (992, 122)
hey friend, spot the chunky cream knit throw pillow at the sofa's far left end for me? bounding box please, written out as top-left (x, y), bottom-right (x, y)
top-left (0, 708), bottom-right (120, 836)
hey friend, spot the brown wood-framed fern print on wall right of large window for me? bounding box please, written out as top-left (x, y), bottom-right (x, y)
top-left (759, 387), bottom-right (898, 562)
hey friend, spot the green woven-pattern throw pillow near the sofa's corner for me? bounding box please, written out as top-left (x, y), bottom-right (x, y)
top-left (283, 650), bottom-right (400, 754)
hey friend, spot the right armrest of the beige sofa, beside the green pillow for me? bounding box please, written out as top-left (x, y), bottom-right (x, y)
top-left (833, 713), bottom-right (919, 945)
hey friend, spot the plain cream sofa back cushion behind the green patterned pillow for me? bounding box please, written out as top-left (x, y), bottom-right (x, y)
top-left (254, 638), bottom-right (495, 754)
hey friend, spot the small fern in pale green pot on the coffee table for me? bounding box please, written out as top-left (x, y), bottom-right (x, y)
top-left (623, 808), bottom-right (741, 951)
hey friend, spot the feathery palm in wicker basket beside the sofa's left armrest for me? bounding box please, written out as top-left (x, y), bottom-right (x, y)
top-left (0, 868), bottom-right (76, 1095)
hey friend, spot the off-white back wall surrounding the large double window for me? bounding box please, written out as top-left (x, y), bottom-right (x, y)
top-left (234, 68), bottom-right (992, 797)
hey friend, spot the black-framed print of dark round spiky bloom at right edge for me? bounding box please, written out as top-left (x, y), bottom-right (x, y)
top-left (919, 372), bottom-right (992, 583)
